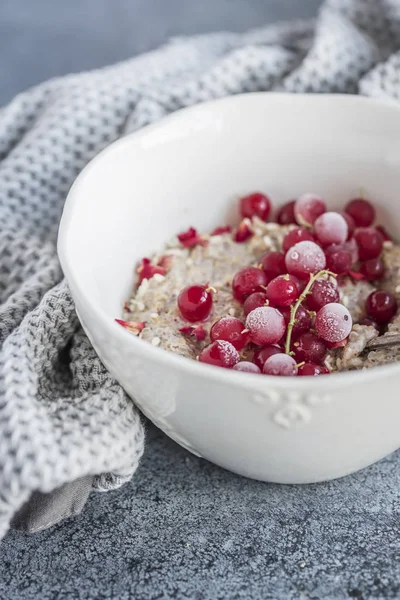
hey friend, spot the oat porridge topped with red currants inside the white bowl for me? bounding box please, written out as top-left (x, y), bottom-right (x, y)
top-left (117, 192), bottom-right (400, 376)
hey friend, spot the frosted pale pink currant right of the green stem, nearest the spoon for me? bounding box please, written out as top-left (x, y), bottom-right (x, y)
top-left (314, 302), bottom-right (353, 343)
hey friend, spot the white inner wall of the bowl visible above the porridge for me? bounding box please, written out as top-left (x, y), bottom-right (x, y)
top-left (59, 94), bottom-right (400, 319)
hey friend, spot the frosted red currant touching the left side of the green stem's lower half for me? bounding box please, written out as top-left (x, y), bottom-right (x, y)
top-left (246, 306), bottom-right (286, 346)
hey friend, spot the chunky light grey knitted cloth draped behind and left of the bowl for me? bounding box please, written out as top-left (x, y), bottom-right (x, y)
top-left (0, 0), bottom-right (400, 537)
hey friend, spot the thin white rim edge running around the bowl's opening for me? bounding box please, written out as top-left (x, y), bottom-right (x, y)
top-left (57, 92), bottom-right (400, 393)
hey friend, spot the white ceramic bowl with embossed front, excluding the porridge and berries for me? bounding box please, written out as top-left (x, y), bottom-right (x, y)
top-left (58, 93), bottom-right (400, 483)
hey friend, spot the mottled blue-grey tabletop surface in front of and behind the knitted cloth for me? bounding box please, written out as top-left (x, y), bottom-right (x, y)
top-left (0, 0), bottom-right (400, 600)
